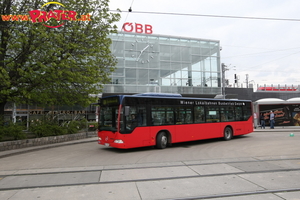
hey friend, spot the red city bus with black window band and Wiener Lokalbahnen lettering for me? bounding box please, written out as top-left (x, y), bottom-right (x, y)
top-left (98, 93), bottom-right (253, 149)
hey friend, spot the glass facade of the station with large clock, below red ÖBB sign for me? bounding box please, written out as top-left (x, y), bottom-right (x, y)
top-left (103, 32), bottom-right (221, 94)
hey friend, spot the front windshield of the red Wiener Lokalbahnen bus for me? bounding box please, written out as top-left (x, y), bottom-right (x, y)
top-left (99, 106), bottom-right (119, 132)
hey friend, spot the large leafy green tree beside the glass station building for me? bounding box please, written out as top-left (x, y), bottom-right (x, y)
top-left (0, 0), bottom-right (120, 119)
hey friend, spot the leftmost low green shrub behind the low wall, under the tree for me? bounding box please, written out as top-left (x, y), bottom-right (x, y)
top-left (0, 123), bottom-right (26, 141)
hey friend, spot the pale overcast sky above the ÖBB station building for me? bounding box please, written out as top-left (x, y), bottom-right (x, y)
top-left (109, 0), bottom-right (300, 87)
